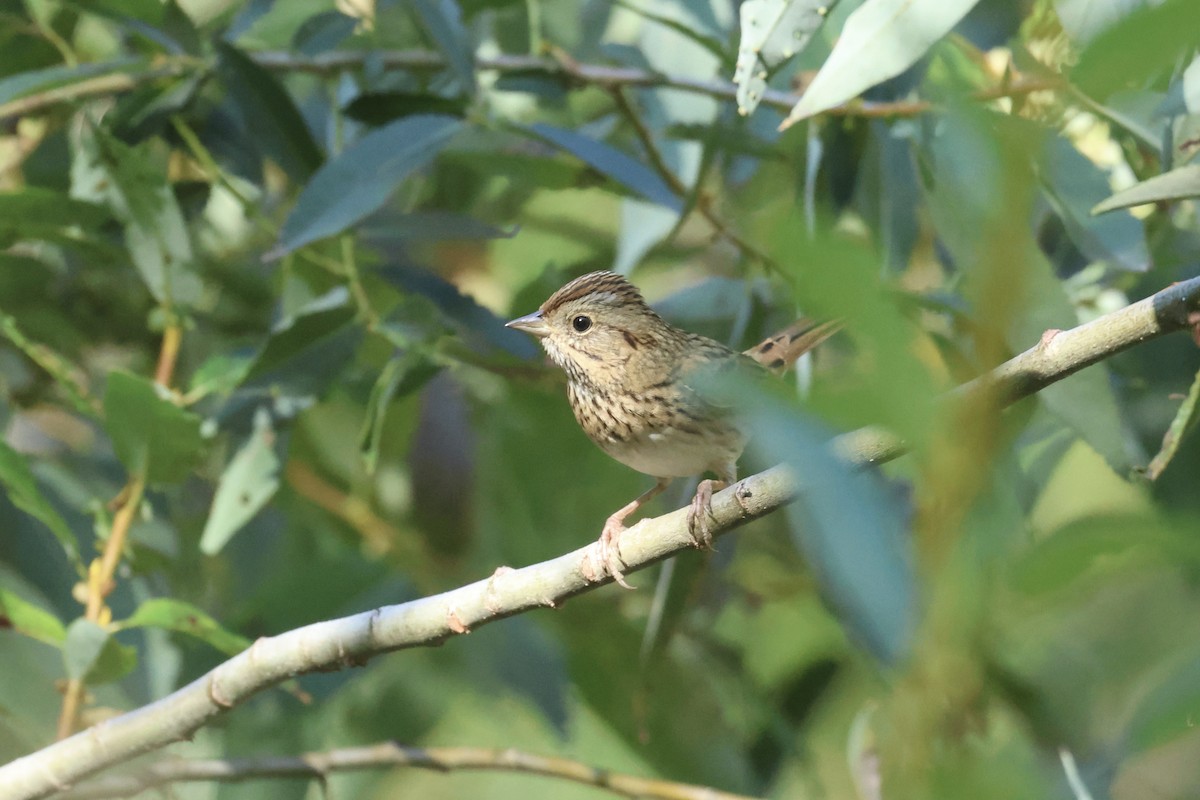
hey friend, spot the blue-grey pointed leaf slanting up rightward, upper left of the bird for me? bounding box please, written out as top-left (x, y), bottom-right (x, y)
top-left (269, 115), bottom-right (461, 257)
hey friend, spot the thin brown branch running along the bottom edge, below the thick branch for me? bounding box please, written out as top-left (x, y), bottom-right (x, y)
top-left (64, 741), bottom-right (750, 800)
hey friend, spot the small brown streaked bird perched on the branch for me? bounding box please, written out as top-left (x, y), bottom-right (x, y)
top-left (508, 271), bottom-right (839, 588)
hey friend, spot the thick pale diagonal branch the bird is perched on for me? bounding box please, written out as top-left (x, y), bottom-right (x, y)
top-left (0, 278), bottom-right (1200, 800)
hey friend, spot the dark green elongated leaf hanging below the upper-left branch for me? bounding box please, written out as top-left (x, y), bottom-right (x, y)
top-left (217, 42), bottom-right (324, 184)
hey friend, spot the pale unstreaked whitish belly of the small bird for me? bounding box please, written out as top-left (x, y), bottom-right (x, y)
top-left (596, 426), bottom-right (745, 477)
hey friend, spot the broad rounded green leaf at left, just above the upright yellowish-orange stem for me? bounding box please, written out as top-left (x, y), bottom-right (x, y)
top-left (104, 372), bottom-right (205, 483)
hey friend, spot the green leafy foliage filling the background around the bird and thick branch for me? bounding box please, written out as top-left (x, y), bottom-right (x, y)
top-left (0, 0), bottom-right (1200, 798)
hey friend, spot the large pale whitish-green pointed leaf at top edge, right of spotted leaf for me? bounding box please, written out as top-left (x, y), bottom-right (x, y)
top-left (781, 0), bottom-right (978, 127)
